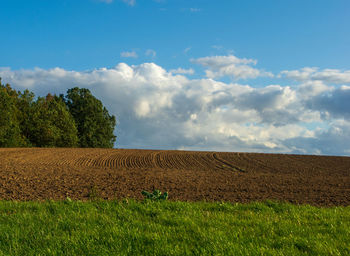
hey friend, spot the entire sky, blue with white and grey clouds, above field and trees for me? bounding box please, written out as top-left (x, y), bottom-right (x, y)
top-left (0, 0), bottom-right (350, 156)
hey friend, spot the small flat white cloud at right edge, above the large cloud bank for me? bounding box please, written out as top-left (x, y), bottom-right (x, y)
top-left (279, 67), bottom-right (350, 84)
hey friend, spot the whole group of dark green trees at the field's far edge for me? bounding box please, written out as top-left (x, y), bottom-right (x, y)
top-left (0, 78), bottom-right (116, 148)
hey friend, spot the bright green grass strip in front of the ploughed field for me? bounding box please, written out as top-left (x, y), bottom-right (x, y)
top-left (0, 200), bottom-right (350, 255)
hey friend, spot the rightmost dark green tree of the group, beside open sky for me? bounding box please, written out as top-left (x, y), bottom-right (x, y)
top-left (65, 87), bottom-right (116, 148)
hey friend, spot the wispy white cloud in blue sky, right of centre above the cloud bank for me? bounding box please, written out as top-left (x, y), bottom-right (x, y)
top-left (191, 55), bottom-right (273, 80)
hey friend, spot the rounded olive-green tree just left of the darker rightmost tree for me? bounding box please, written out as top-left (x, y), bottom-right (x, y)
top-left (25, 94), bottom-right (78, 147)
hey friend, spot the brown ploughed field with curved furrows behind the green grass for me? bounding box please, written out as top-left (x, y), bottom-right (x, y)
top-left (0, 148), bottom-right (350, 206)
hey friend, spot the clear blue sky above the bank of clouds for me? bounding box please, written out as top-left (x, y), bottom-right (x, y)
top-left (0, 0), bottom-right (350, 71)
